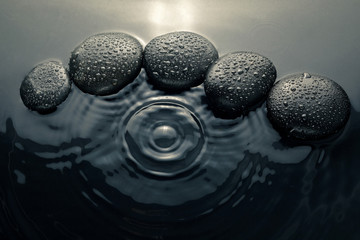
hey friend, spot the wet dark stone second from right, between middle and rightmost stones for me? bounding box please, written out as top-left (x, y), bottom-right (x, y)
top-left (204, 52), bottom-right (276, 118)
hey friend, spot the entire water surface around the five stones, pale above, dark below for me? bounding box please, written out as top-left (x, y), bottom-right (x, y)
top-left (0, 0), bottom-right (360, 240)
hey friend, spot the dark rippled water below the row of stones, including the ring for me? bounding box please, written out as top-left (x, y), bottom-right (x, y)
top-left (1, 72), bottom-right (359, 239)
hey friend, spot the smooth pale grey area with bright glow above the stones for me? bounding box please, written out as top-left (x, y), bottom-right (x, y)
top-left (0, 0), bottom-right (360, 119)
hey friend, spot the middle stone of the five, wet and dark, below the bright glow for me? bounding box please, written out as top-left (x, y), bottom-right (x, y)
top-left (144, 32), bottom-right (218, 91)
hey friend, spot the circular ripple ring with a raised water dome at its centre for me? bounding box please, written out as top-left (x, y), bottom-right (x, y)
top-left (124, 101), bottom-right (205, 176)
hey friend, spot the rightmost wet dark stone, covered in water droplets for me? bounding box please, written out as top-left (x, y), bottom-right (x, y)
top-left (267, 73), bottom-right (351, 140)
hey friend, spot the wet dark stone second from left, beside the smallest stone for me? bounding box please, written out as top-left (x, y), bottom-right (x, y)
top-left (69, 32), bottom-right (143, 95)
